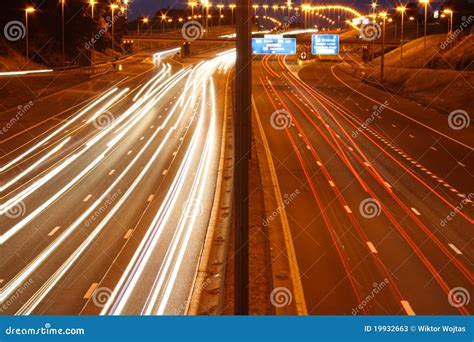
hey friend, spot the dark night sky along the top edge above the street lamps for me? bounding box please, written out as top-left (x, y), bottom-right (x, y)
top-left (125, 0), bottom-right (434, 19)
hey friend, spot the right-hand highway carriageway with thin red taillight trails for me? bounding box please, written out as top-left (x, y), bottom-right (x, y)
top-left (253, 56), bottom-right (474, 315)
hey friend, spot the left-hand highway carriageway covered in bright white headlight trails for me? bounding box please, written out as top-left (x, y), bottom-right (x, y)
top-left (0, 50), bottom-right (235, 315)
